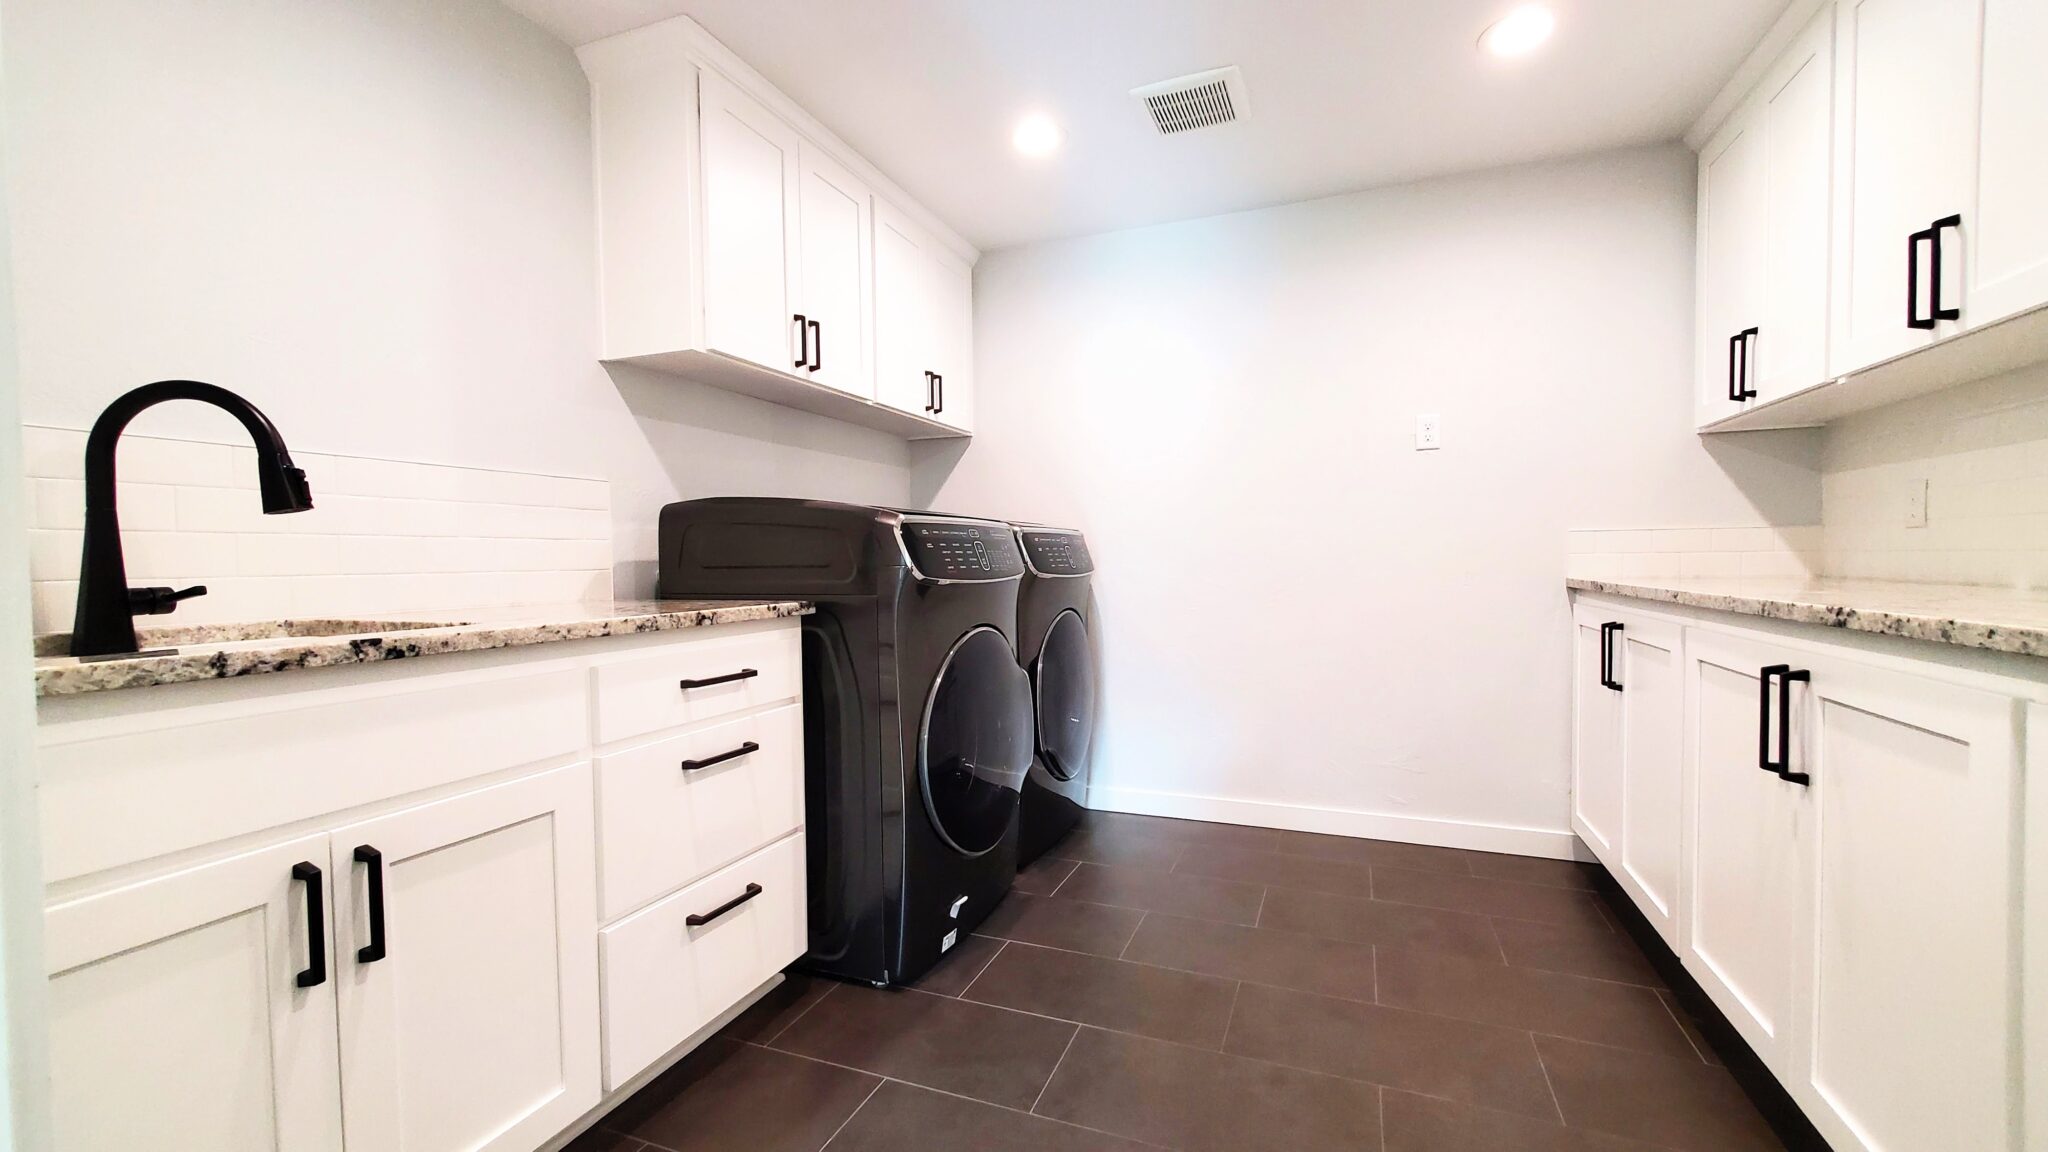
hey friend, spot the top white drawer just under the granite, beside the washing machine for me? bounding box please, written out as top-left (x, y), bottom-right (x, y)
top-left (596, 623), bottom-right (803, 744)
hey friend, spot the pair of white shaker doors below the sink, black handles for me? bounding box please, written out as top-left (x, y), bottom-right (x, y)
top-left (45, 765), bottom-right (600, 1152)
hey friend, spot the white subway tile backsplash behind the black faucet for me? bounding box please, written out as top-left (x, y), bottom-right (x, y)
top-left (23, 424), bottom-right (612, 631)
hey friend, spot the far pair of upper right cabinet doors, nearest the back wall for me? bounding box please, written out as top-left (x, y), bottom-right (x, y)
top-left (1696, 6), bottom-right (1835, 424)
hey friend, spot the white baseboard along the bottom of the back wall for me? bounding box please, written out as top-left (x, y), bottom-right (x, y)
top-left (1087, 787), bottom-right (1595, 861)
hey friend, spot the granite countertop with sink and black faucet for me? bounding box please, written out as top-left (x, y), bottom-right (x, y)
top-left (35, 601), bottom-right (811, 697)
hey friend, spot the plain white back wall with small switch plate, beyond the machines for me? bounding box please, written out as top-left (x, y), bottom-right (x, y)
top-left (915, 148), bottom-right (1819, 851)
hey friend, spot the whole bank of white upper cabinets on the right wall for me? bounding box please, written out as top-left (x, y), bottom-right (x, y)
top-left (1698, 0), bottom-right (2048, 430)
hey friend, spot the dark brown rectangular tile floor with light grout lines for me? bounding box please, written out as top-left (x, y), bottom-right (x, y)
top-left (571, 812), bottom-right (1782, 1152)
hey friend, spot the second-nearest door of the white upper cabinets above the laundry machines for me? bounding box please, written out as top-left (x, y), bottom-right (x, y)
top-left (797, 141), bottom-right (874, 400)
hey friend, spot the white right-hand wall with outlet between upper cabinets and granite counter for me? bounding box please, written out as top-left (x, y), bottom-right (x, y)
top-left (1821, 365), bottom-right (2048, 588)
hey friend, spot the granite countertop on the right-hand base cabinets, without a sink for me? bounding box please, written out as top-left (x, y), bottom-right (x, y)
top-left (1565, 576), bottom-right (2048, 656)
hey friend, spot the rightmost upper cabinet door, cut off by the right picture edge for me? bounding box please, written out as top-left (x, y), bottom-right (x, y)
top-left (1968, 0), bottom-right (2048, 324)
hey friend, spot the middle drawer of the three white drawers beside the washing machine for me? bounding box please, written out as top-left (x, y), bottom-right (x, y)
top-left (598, 703), bottom-right (803, 920)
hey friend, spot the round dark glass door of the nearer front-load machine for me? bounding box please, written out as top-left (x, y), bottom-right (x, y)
top-left (918, 625), bottom-right (1032, 857)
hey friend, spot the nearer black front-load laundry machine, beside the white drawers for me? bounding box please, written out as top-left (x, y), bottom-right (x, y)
top-left (659, 496), bottom-right (1032, 984)
